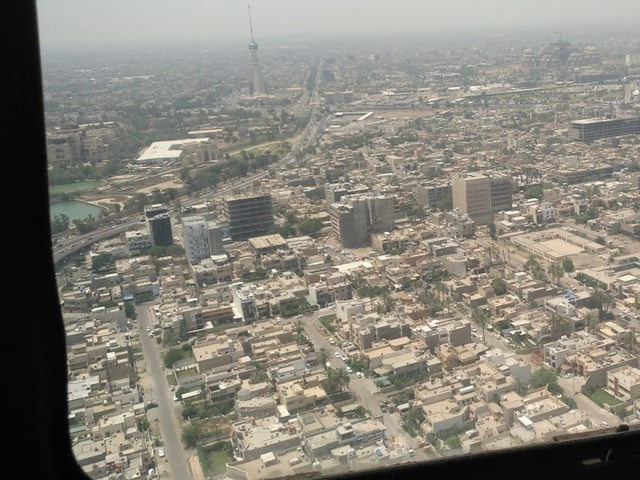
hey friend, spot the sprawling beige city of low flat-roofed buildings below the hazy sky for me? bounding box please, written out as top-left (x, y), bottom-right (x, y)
top-left (43, 32), bottom-right (640, 480)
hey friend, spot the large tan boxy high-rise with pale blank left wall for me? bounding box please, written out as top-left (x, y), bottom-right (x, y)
top-left (451, 172), bottom-right (513, 225)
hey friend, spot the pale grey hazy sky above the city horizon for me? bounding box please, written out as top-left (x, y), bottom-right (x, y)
top-left (37, 0), bottom-right (640, 50)
